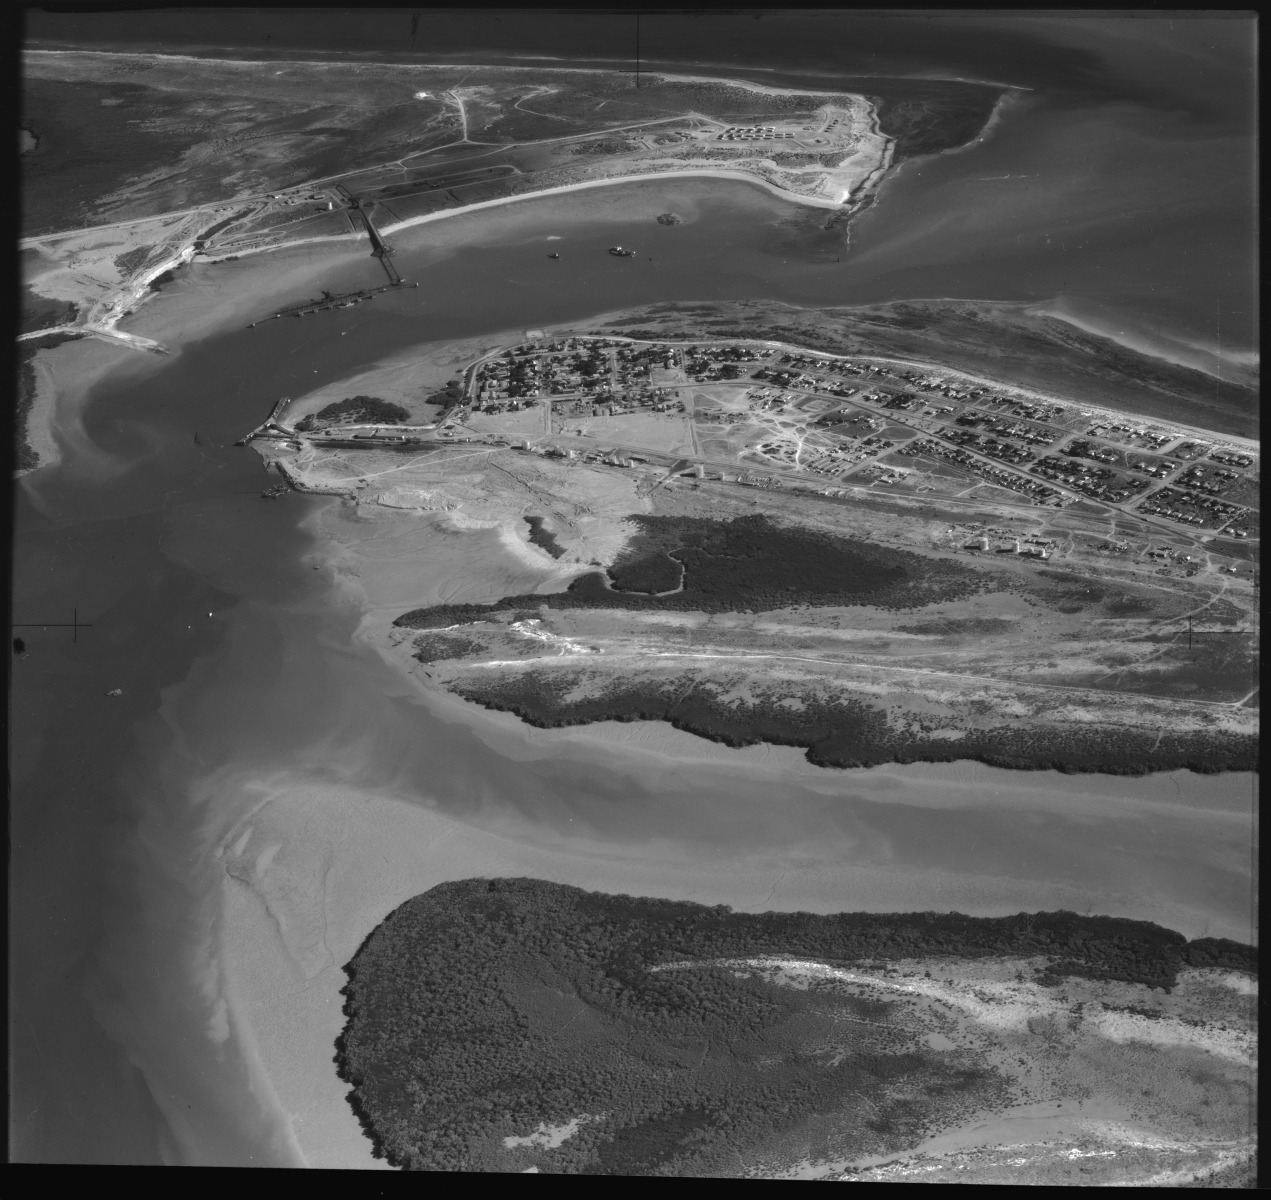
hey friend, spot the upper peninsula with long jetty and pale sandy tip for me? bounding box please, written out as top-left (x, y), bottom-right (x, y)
top-left (20, 50), bottom-right (1007, 396)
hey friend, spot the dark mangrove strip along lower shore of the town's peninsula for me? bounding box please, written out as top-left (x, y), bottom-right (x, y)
top-left (450, 666), bottom-right (1257, 775)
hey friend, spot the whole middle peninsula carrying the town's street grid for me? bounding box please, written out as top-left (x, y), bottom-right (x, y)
top-left (245, 303), bottom-right (1261, 774)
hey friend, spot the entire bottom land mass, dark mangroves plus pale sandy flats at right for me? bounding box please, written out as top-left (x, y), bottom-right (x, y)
top-left (338, 878), bottom-right (1257, 1186)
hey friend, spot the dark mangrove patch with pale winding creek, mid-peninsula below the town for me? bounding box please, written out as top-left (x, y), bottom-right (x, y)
top-left (394, 515), bottom-right (1002, 629)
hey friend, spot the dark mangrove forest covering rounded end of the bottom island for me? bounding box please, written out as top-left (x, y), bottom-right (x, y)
top-left (337, 878), bottom-right (1256, 1176)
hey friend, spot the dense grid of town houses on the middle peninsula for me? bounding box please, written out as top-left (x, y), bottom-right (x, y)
top-left (465, 338), bottom-right (1256, 536)
